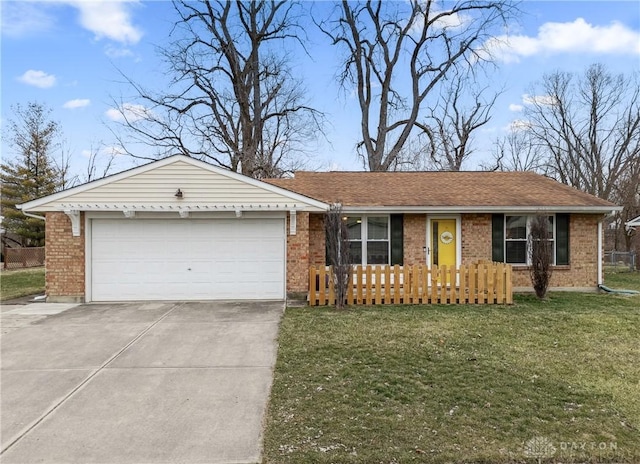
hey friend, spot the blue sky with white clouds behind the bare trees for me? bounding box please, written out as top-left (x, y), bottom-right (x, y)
top-left (0, 0), bottom-right (640, 180)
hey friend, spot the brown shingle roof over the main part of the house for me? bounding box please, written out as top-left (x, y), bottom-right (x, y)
top-left (267, 171), bottom-right (615, 211)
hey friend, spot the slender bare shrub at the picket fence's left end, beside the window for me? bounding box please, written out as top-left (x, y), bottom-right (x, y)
top-left (324, 204), bottom-right (352, 309)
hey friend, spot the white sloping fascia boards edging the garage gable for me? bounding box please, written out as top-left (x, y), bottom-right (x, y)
top-left (16, 155), bottom-right (329, 212)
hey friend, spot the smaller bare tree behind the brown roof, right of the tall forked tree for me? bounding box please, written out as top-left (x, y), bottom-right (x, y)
top-left (423, 73), bottom-right (500, 171)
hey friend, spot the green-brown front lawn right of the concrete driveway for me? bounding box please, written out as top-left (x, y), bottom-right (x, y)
top-left (264, 273), bottom-right (640, 463)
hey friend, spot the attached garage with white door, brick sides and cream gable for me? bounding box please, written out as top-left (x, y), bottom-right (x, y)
top-left (17, 155), bottom-right (328, 302)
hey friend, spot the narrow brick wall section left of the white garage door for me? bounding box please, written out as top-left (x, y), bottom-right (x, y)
top-left (45, 213), bottom-right (85, 302)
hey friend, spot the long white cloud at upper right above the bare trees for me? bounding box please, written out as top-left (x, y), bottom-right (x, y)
top-left (483, 18), bottom-right (640, 63)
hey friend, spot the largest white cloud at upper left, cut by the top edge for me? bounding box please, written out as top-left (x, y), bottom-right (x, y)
top-left (68, 0), bottom-right (142, 44)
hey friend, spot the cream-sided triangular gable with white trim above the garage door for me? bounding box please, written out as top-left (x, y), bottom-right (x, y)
top-left (22, 155), bottom-right (327, 212)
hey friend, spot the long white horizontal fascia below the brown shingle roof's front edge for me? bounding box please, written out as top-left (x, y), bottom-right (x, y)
top-left (342, 206), bottom-right (622, 214)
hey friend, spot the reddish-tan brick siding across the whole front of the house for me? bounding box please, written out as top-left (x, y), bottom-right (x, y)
top-left (45, 208), bottom-right (600, 301)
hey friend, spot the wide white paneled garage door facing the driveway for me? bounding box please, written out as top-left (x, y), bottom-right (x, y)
top-left (91, 218), bottom-right (285, 301)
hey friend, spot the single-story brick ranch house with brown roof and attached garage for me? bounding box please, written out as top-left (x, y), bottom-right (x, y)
top-left (22, 155), bottom-right (619, 301)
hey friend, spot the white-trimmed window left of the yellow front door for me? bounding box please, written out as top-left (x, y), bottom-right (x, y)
top-left (343, 215), bottom-right (390, 264)
